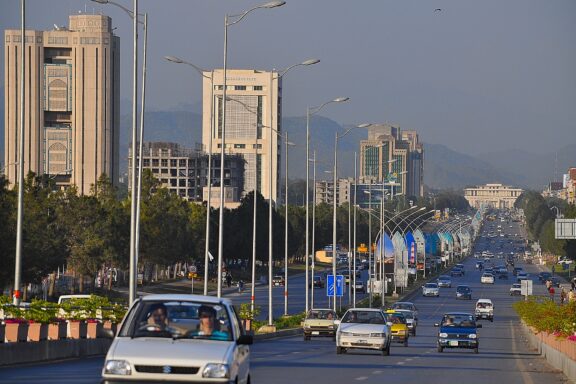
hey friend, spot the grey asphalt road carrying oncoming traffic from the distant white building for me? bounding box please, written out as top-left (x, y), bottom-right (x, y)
top-left (0, 214), bottom-right (568, 384)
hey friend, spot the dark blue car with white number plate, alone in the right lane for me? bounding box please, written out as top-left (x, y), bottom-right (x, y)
top-left (434, 312), bottom-right (482, 353)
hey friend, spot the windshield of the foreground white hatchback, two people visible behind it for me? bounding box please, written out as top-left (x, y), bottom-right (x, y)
top-left (119, 300), bottom-right (232, 341)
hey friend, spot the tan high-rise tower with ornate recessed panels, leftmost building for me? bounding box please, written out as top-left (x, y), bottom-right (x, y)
top-left (4, 14), bottom-right (120, 194)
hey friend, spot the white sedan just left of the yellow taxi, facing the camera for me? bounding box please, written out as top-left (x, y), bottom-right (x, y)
top-left (334, 308), bottom-right (391, 356)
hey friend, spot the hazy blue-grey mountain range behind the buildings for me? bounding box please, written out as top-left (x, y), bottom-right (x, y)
top-left (0, 95), bottom-right (576, 190)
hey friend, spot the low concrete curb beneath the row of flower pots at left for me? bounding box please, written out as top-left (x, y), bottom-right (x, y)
top-left (0, 339), bottom-right (112, 366)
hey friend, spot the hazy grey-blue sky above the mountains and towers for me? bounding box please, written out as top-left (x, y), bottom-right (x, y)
top-left (0, 0), bottom-right (576, 154)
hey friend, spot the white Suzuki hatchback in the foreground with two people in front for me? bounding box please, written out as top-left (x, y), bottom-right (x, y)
top-left (102, 295), bottom-right (252, 383)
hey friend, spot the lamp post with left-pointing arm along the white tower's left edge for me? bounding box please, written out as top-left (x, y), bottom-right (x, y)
top-left (164, 56), bottom-right (215, 296)
